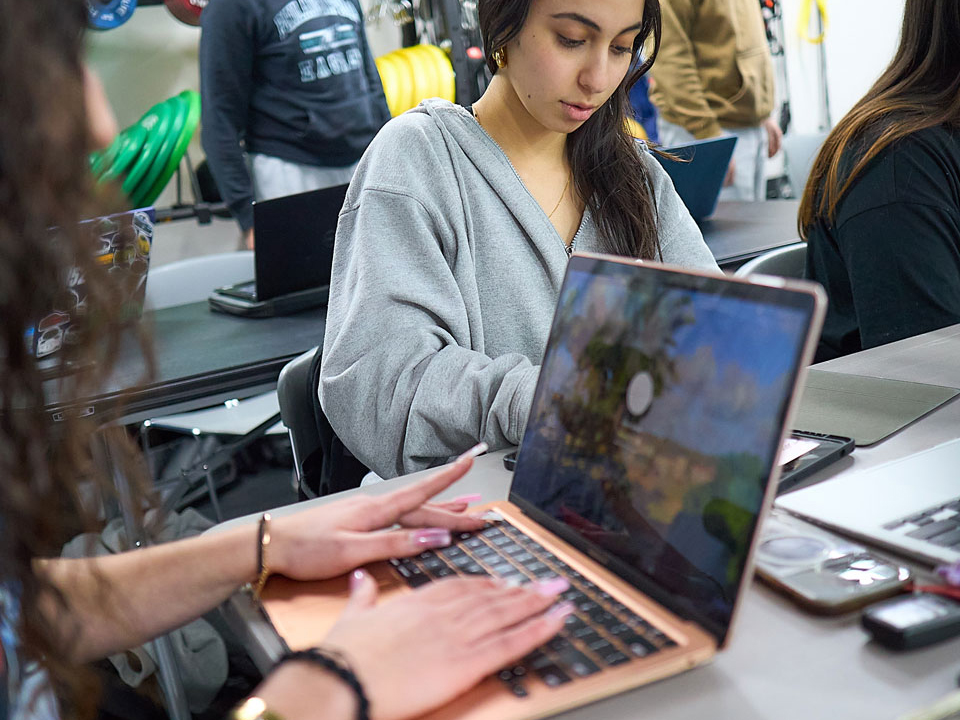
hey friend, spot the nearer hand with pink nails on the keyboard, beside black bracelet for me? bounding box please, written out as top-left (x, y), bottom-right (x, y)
top-left (323, 570), bottom-right (573, 720)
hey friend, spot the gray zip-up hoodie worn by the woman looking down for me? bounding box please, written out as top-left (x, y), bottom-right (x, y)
top-left (319, 100), bottom-right (719, 478)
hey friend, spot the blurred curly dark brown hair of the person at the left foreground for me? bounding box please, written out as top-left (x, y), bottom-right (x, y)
top-left (0, 0), bottom-right (150, 716)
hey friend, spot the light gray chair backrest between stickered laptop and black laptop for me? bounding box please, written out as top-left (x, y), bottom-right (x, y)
top-left (143, 250), bottom-right (254, 310)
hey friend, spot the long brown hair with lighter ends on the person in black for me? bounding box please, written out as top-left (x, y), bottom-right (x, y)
top-left (798, 0), bottom-right (960, 237)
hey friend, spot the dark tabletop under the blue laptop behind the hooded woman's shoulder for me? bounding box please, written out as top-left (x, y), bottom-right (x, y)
top-left (698, 200), bottom-right (800, 269)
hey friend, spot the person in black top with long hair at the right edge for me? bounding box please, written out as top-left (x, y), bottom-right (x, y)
top-left (799, 0), bottom-right (960, 362)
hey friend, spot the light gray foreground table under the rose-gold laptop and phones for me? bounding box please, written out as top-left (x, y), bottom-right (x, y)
top-left (214, 326), bottom-right (960, 720)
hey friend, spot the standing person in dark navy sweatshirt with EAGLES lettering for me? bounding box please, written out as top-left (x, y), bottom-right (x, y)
top-left (200, 0), bottom-right (390, 247)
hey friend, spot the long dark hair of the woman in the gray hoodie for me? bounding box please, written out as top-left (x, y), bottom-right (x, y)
top-left (479, 0), bottom-right (660, 260)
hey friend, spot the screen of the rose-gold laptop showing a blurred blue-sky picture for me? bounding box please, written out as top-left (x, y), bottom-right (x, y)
top-left (510, 256), bottom-right (815, 643)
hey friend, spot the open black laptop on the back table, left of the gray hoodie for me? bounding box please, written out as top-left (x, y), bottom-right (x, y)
top-left (209, 185), bottom-right (349, 316)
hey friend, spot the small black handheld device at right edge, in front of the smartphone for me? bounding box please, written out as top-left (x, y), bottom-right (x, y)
top-left (861, 593), bottom-right (960, 650)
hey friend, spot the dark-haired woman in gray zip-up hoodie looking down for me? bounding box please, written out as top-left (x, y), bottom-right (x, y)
top-left (319, 0), bottom-right (717, 484)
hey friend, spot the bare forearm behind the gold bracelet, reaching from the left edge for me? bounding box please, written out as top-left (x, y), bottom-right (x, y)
top-left (37, 523), bottom-right (258, 661)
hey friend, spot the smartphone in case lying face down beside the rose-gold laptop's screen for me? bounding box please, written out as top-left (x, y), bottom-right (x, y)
top-left (757, 509), bottom-right (911, 615)
